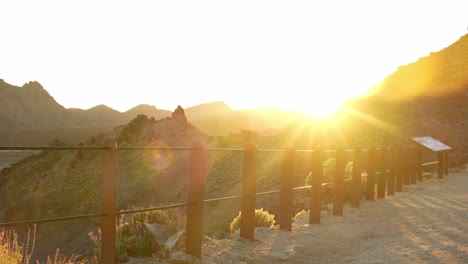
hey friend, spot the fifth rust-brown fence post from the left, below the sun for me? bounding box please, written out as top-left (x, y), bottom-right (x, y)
top-left (309, 147), bottom-right (323, 224)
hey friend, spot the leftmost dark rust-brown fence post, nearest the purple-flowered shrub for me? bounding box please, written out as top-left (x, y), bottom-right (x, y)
top-left (101, 138), bottom-right (117, 263)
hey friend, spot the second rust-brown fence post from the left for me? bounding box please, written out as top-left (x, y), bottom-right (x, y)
top-left (185, 141), bottom-right (207, 258)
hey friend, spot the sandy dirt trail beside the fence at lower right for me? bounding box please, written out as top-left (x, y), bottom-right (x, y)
top-left (201, 173), bottom-right (468, 263)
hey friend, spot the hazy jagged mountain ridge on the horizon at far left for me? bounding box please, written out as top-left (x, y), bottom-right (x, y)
top-left (0, 79), bottom-right (171, 132)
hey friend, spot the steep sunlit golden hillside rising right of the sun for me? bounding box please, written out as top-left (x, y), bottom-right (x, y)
top-left (348, 35), bottom-right (468, 165)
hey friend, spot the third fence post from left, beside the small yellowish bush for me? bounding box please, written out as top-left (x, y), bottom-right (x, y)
top-left (240, 144), bottom-right (258, 241)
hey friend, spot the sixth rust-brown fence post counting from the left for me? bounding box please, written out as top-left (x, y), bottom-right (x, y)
top-left (333, 148), bottom-right (345, 215)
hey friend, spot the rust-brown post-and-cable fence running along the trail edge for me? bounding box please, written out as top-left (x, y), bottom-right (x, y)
top-left (0, 138), bottom-right (448, 263)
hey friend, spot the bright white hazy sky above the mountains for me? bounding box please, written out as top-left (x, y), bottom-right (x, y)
top-left (0, 0), bottom-right (468, 111)
